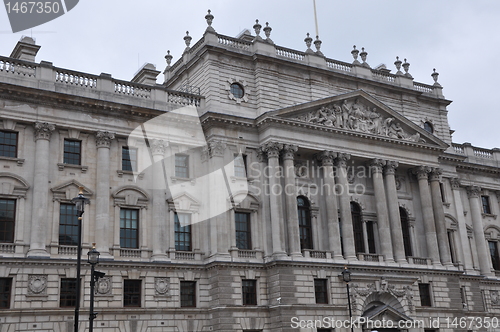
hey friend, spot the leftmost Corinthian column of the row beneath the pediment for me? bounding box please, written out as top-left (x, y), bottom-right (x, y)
top-left (261, 142), bottom-right (286, 256)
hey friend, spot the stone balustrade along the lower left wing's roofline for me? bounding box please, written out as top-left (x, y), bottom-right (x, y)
top-left (0, 57), bottom-right (204, 108)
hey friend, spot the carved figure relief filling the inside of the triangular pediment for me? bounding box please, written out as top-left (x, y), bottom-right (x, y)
top-left (294, 99), bottom-right (424, 142)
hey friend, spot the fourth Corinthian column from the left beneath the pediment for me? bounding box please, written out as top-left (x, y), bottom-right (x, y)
top-left (335, 153), bottom-right (357, 260)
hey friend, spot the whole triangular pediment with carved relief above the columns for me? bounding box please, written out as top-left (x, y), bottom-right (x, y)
top-left (266, 90), bottom-right (448, 149)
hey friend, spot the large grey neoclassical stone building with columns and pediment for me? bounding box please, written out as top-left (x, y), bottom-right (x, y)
top-left (0, 12), bottom-right (500, 332)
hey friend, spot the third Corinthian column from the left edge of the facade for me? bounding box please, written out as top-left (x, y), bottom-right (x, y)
top-left (150, 139), bottom-right (169, 261)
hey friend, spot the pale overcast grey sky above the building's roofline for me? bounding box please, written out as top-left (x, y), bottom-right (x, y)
top-left (0, 0), bottom-right (500, 148)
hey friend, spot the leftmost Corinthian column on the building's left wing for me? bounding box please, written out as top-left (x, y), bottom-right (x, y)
top-left (28, 122), bottom-right (56, 257)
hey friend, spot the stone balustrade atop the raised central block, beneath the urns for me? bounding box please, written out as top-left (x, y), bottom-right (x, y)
top-left (165, 31), bottom-right (444, 98)
